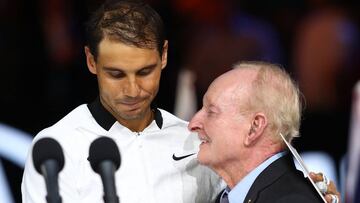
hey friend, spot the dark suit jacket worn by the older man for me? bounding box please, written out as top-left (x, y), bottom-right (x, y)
top-left (217, 153), bottom-right (323, 203)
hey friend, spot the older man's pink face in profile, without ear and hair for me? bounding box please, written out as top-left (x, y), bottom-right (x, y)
top-left (189, 70), bottom-right (254, 169)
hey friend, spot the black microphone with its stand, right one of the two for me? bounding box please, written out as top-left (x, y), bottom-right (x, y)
top-left (88, 137), bottom-right (121, 203)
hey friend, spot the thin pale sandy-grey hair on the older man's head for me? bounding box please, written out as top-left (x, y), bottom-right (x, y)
top-left (233, 61), bottom-right (302, 142)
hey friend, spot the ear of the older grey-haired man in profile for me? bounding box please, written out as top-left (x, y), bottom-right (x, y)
top-left (245, 113), bottom-right (268, 146)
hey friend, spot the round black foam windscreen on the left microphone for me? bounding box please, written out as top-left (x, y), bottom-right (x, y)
top-left (32, 137), bottom-right (64, 174)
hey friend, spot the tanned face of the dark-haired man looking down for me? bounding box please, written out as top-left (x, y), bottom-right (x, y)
top-left (85, 38), bottom-right (167, 131)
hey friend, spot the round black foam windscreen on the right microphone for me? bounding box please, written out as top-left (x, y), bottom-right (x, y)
top-left (88, 137), bottom-right (121, 173)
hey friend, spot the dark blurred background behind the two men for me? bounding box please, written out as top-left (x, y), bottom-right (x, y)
top-left (0, 0), bottom-right (360, 202)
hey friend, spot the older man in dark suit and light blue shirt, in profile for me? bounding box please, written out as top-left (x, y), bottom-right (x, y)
top-left (189, 62), bottom-right (336, 203)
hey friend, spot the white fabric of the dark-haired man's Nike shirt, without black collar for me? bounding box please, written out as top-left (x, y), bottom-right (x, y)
top-left (21, 105), bottom-right (224, 203)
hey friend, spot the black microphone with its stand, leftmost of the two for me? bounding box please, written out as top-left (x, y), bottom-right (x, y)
top-left (32, 138), bottom-right (64, 203)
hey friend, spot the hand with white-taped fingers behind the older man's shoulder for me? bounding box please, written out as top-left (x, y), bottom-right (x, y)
top-left (309, 172), bottom-right (341, 203)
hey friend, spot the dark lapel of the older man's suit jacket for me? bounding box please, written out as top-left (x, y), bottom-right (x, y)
top-left (244, 153), bottom-right (295, 203)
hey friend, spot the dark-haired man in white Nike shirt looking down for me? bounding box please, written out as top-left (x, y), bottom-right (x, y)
top-left (22, 1), bottom-right (224, 203)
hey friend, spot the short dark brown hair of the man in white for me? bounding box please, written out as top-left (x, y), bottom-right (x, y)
top-left (86, 0), bottom-right (165, 60)
